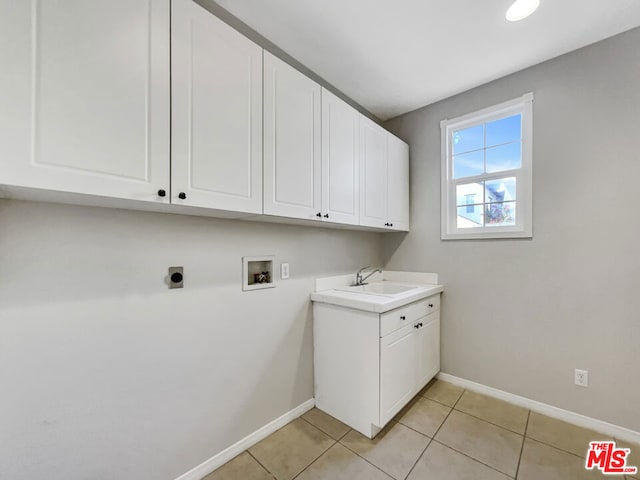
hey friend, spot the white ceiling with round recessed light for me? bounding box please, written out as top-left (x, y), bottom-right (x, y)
top-left (216, 0), bottom-right (640, 120)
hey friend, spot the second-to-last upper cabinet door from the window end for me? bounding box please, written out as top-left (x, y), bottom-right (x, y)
top-left (360, 116), bottom-right (389, 228)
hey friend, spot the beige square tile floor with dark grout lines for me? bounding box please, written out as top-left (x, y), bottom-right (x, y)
top-left (203, 380), bottom-right (640, 480)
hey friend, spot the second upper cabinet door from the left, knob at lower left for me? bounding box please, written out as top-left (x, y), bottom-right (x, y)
top-left (171, 0), bottom-right (262, 213)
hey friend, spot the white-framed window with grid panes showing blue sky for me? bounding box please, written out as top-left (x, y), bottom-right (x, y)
top-left (440, 93), bottom-right (533, 240)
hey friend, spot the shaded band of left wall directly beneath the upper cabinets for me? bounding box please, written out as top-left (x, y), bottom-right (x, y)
top-left (0, 200), bottom-right (382, 308)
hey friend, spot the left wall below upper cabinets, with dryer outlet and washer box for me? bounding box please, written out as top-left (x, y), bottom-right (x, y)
top-left (0, 200), bottom-right (382, 480)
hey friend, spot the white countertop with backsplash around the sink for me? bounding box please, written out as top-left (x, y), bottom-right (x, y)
top-left (311, 272), bottom-right (444, 313)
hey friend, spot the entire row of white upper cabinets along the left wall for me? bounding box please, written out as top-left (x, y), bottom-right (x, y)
top-left (0, 0), bottom-right (409, 230)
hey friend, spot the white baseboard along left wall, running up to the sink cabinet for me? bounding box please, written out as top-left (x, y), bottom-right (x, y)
top-left (176, 398), bottom-right (315, 480)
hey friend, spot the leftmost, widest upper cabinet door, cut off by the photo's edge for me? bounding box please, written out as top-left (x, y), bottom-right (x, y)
top-left (0, 0), bottom-right (169, 202)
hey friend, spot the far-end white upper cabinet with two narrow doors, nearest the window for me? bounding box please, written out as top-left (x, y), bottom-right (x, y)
top-left (360, 117), bottom-right (409, 230)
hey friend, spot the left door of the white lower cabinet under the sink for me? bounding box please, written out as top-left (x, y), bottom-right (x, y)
top-left (380, 322), bottom-right (420, 426)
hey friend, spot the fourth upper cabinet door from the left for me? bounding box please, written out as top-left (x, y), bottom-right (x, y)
top-left (322, 88), bottom-right (360, 225)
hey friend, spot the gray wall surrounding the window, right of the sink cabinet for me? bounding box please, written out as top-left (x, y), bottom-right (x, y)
top-left (384, 29), bottom-right (640, 431)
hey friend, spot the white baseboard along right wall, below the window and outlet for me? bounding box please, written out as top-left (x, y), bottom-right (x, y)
top-left (438, 372), bottom-right (640, 444)
